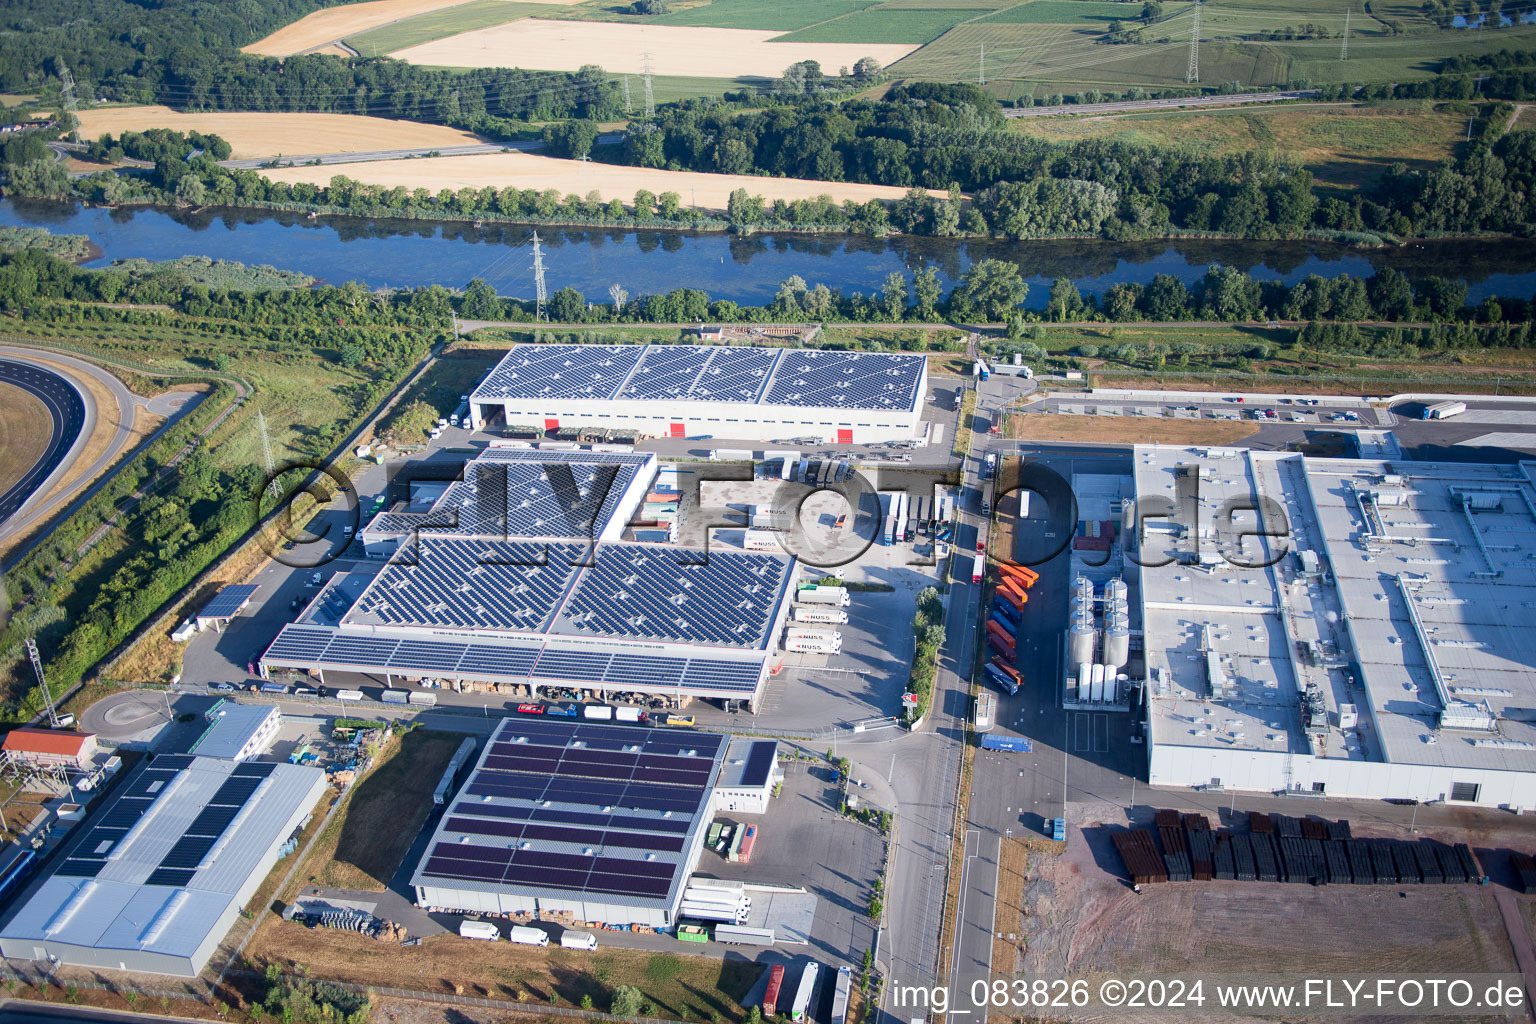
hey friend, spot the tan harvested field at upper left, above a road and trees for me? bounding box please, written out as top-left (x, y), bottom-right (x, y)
top-left (78, 106), bottom-right (485, 160)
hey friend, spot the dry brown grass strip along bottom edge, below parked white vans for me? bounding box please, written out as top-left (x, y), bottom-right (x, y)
top-left (247, 915), bottom-right (763, 1021)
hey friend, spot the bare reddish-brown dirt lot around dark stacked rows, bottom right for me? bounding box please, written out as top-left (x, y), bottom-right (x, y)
top-left (998, 806), bottom-right (1528, 1019)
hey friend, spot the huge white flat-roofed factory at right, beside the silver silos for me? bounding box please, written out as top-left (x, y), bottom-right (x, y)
top-left (1130, 445), bottom-right (1536, 809)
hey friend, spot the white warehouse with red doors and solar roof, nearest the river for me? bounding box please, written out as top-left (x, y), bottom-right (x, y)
top-left (470, 345), bottom-right (928, 444)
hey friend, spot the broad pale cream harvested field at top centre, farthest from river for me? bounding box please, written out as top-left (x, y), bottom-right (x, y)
top-left (390, 15), bottom-right (917, 78)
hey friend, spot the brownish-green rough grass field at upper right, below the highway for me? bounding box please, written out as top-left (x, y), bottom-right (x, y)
top-left (1009, 101), bottom-right (1467, 189)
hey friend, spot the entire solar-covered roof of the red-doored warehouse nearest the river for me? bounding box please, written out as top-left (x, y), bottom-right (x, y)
top-left (472, 345), bottom-right (926, 410)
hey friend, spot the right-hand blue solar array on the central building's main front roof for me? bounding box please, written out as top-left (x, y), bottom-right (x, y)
top-left (551, 545), bottom-right (793, 648)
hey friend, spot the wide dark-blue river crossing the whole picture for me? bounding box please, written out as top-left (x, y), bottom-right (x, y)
top-left (0, 200), bottom-right (1536, 309)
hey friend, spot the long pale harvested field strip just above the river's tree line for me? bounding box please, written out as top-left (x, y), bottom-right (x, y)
top-left (261, 152), bottom-right (943, 210)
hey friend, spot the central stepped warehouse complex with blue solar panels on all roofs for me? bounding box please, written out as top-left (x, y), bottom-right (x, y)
top-left (261, 448), bottom-right (794, 706)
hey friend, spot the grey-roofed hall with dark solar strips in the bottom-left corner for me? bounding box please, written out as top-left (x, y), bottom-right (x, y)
top-left (0, 755), bottom-right (326, 978)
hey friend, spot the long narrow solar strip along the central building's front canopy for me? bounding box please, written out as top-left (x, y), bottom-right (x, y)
top-left (261, 623), bottom-right (763, 694)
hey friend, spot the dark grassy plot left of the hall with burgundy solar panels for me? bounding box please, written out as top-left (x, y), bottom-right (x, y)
top-left (304, 729), bottom-right (464, 892)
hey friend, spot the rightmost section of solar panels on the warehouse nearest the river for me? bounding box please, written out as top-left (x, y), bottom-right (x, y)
top-left (762, 348), bottom-right (923, 408)
